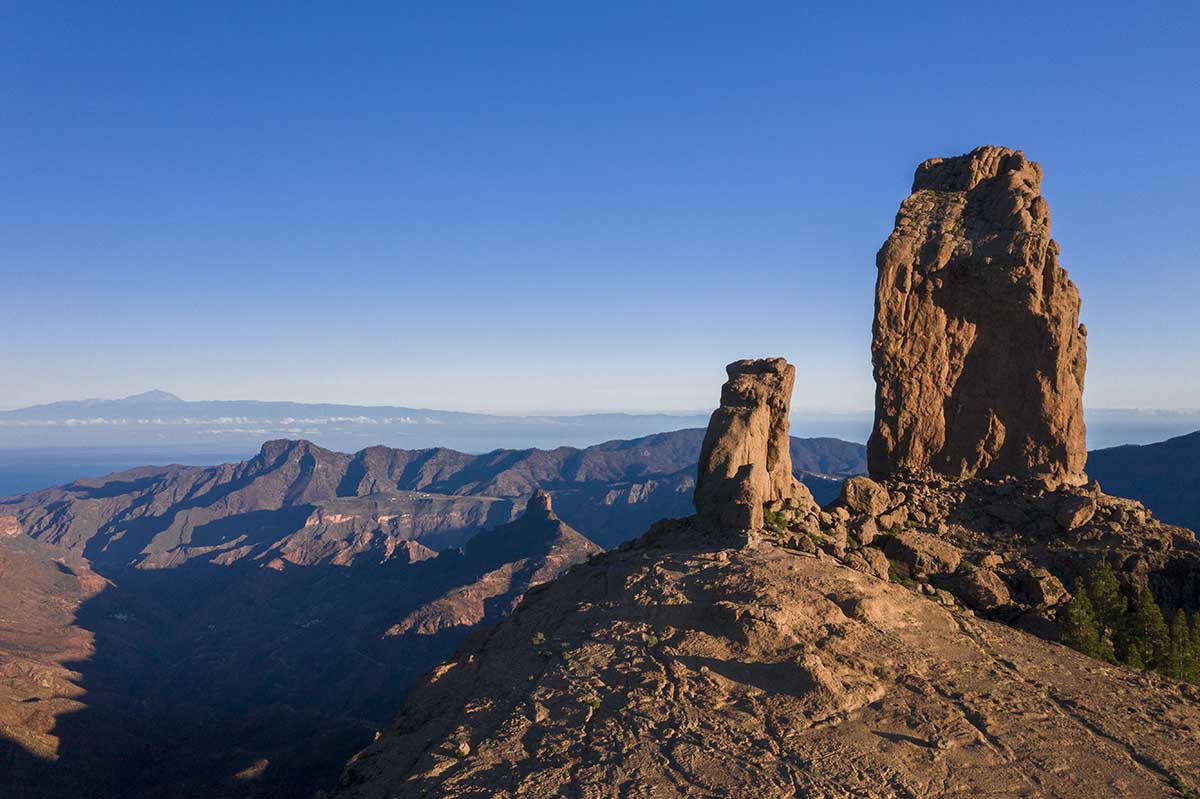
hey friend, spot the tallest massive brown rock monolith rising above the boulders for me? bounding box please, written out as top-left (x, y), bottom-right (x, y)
top-left (868, 146), bottom-right (1087, 481)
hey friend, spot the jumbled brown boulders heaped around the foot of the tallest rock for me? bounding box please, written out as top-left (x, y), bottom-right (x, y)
top-left (767, 476), bottom-right (1200, 639)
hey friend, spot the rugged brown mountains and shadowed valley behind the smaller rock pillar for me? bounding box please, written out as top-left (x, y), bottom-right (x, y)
top-left (0, 429), bottom-right (865, 799)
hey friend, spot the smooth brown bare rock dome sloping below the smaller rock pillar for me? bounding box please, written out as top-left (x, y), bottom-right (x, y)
top-left (336, 519), bottom-right (1200, 799)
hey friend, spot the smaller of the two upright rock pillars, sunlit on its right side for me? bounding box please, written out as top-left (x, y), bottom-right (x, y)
top-left (695, 358), bottom-right (808, 529)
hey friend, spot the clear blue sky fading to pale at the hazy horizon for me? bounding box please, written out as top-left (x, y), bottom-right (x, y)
top-left (0, 1), bottom-right (1200, 411)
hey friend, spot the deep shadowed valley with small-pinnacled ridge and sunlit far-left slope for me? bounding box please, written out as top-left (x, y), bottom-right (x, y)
top-left (0, 494), bottom-right (600, 799)
